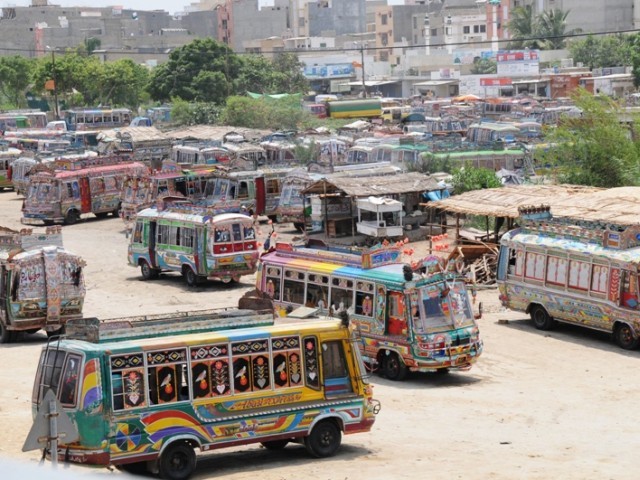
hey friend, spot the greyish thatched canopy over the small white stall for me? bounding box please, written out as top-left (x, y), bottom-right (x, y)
top-left (302, 172), bottom-right (442, 197)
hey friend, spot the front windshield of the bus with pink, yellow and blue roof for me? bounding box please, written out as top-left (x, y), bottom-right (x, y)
top-left (414, 282), bottom-right (474, 334)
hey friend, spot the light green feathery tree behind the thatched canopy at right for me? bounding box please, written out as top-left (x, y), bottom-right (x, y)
top-left (543, 89), bottom-right (640, 188)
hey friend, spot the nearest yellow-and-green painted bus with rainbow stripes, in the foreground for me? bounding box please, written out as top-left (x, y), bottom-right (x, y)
top-left (32, 311), bottom-right (380, 480)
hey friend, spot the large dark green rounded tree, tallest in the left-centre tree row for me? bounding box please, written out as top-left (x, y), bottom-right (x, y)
top-left (147, 38), bottom-right (241, 103)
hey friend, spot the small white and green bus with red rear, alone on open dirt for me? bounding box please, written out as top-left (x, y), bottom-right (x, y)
top-left (128, 204), bottom-right (259, 286)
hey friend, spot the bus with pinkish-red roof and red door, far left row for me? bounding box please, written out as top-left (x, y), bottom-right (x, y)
top-left (22, 157), bottom-right (147, 225)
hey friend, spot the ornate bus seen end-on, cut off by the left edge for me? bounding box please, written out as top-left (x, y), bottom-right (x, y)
top-left (0, 227), bottom-right (85, 343)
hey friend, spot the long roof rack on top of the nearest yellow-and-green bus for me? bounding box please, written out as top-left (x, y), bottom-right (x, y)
top-left (65, 308), bottom-right (274, 343)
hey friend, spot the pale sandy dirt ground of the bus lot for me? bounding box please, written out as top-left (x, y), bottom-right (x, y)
top-left (0, 192), bottom-right (640, 480)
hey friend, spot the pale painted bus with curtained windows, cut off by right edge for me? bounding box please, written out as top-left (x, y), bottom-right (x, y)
top-left (497, 206), bottom-right (640, 350)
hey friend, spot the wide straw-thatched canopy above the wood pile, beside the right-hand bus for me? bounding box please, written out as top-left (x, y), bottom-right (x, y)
top-left (425, 185), bottom-right (604, 220)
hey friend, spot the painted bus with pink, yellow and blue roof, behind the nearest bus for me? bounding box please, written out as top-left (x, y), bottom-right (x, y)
top-left (256, 243), bottom-right (482, 380)
